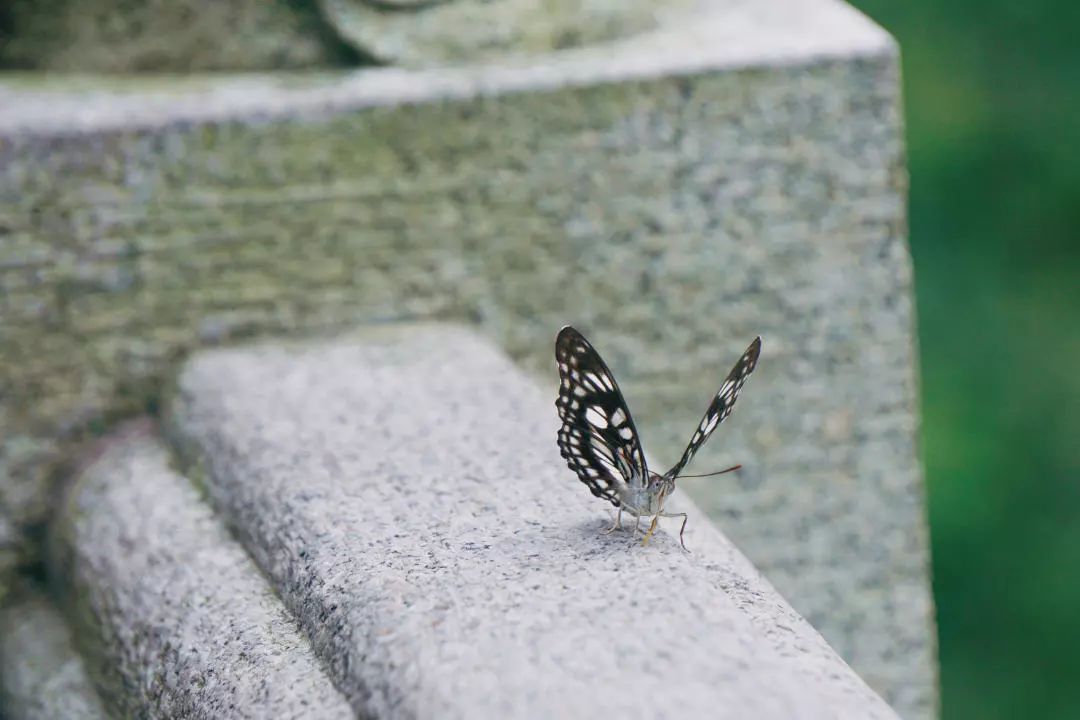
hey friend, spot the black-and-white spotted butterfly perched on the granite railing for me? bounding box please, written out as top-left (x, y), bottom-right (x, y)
top-left (555, 325), bottom-right (761, 549)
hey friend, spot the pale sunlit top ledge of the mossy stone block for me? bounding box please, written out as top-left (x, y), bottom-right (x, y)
top-left (0, 0), bottom-right (896, 138)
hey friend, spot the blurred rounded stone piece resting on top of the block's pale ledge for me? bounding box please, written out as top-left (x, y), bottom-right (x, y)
top-left (319, 0), bottom-right (691, 66)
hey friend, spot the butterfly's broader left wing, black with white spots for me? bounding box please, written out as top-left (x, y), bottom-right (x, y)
top-left (555, 325), bottom-right (649, 507)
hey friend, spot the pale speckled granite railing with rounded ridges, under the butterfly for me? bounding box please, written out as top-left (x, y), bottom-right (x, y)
top-left (2, 326), bottom-right (896, 719)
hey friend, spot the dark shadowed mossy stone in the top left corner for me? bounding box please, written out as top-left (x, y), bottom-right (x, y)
top-left (0, 0), bottom-right (354, 72)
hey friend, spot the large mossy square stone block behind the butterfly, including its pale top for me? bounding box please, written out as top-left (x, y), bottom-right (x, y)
top-left (0, 0), bottom-right (934, 718)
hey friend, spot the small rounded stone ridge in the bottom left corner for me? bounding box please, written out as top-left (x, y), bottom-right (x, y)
top-left (0, 590), bottom-right (108, 720)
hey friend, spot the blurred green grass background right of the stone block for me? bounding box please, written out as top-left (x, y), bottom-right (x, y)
top-left (853, 0), bottom-right (1080, 720)
